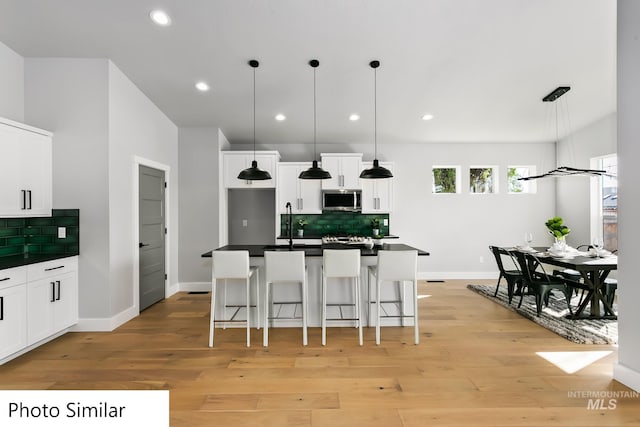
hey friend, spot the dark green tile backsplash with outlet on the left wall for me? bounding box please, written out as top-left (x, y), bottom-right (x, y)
top-left (0, 209), bottom-right (80, 256)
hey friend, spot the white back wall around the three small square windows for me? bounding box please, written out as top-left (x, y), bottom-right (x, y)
top-left (233, 143), bottom-right (556, 279)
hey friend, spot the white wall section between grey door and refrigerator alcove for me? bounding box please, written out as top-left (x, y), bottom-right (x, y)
top-left (178, 128), bottom-right (220, 289)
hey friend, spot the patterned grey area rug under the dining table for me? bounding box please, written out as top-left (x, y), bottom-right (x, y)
top-left (467, 285), bottom-right (618, 344)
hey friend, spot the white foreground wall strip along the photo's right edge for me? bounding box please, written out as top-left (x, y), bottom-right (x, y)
top-left (614, 0), bottom-right (640, 391)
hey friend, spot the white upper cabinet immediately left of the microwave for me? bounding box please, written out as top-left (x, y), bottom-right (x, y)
top-left (278, 162), bottom-right (323, 214)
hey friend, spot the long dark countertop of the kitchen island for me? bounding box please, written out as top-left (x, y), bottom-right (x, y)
top-left (202, 243), bottom-right (429, 258)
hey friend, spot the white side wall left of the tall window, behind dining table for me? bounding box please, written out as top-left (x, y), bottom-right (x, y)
top-left (549, 113), bottom-right (617, 247)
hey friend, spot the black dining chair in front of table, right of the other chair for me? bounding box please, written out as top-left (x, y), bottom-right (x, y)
top-left (510, 251), bottom-right (573, 316)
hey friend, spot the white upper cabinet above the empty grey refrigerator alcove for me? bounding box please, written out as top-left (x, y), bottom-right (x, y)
top-left (222, 151), bottom-right (280, 188)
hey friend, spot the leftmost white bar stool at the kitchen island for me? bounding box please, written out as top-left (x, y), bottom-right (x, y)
top-left (209, 251), bottom-right (260, 347)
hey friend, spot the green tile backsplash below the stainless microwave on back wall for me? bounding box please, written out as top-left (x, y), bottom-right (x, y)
top-left (280, 211), bottom-right (389, 238)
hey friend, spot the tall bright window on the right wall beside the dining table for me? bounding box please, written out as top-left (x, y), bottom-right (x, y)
top-left (591, 154), bottom-right (618, 251)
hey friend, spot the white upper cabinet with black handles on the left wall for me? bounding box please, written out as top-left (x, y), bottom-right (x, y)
top-left (0, 118), bottom-right (52, 217)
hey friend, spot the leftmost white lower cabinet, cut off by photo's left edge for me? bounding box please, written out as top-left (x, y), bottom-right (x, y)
top-left (0, 267), bottom-right (27, 360)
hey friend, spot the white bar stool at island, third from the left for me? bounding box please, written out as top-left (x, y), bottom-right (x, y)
top-left (322, 249), bottom-right (362, 345)
